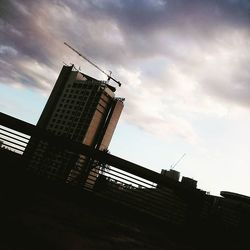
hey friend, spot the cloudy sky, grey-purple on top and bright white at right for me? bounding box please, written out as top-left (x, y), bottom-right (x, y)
top-left (0, 0), bottom-right (250, 196)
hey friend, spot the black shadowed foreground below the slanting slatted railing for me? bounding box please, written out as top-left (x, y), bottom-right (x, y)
top-left (0, 149), bottom-right (250, 250)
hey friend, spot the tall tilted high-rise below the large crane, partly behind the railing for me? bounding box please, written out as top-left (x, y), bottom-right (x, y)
top-left (26, 66), bottom-right (124, 184)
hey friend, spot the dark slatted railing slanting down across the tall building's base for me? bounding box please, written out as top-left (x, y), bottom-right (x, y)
top-left (0, 113), bottom-right (204, 225)
